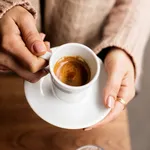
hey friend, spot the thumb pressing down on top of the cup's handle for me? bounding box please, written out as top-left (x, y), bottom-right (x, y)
top-left (18, 13), bottom-right (47, 56)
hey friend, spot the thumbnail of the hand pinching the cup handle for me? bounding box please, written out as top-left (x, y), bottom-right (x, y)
top-left (33, 42), bottom-right (46, 53)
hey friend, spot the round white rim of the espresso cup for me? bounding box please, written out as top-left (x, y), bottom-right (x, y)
top-left (49, 43), bottom-right (100, 90)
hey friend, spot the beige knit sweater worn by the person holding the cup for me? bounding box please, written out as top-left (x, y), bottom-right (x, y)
top-left (0, 0), bottom-right (150, 78)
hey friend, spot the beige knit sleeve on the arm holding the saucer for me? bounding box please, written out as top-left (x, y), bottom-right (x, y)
top-left (95, 0), bottom-right (150, 79)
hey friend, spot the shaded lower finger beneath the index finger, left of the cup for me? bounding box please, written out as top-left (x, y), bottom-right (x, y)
top-left (0, 53), bottom-right (48, 83)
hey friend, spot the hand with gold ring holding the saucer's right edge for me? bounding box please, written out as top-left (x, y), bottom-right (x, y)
top-left (85, 48), bottom-right (135, 130)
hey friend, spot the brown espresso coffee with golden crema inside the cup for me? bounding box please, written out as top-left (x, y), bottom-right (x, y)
top-left (54, 56), bottom-right (91, 86)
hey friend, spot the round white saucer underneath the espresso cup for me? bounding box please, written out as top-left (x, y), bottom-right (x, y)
top-left (24, 47), bottom-right (110, 129)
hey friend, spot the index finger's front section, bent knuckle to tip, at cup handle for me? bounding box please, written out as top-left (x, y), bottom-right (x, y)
top-left (2, 35), bottom-right (47, 73)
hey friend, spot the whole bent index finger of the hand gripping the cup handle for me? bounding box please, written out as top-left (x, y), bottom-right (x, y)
top-left (1, 16), bottom-right (47, 73)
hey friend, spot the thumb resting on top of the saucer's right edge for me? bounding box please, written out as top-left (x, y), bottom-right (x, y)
top-left (103, 69), bottom-right (123, 108)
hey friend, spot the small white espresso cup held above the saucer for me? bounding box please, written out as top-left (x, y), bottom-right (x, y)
top-left (41, 43), bottom-right (100, 103)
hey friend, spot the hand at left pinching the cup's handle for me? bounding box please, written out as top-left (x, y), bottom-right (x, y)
top-left (0, 6), bottom-right (50, 82)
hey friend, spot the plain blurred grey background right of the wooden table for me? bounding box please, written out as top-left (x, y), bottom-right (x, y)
top-left (128, 37), bottom-right (150, 150)
